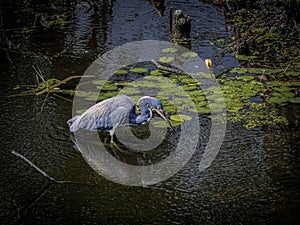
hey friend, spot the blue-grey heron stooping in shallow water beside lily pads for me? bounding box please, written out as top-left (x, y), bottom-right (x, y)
top-left (67, 95), bottom-right (175, 148)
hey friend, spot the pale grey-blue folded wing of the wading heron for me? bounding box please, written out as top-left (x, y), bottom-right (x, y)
top-left (78, 96), bottom-right (134, 130)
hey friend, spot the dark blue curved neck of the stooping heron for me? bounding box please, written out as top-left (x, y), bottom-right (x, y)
top-left (129, 97), bottom-right (152, 124)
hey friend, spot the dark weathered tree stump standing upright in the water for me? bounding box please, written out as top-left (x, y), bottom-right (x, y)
top-left (170, 10), bottom-right (191, 44)
